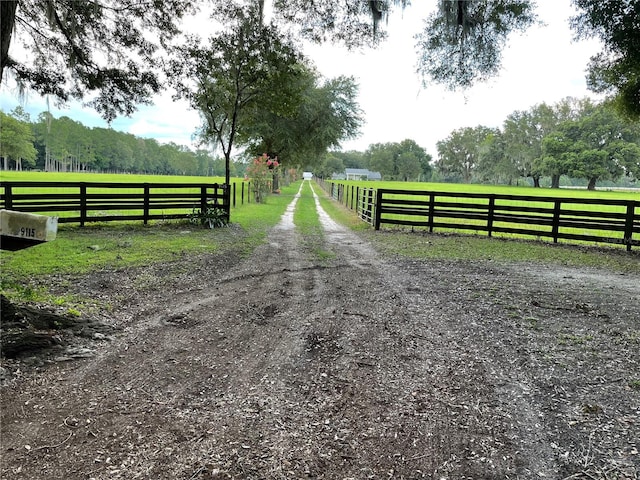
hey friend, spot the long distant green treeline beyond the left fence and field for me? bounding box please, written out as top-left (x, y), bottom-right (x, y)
top-left (0, 107), bottom-right (235, 176)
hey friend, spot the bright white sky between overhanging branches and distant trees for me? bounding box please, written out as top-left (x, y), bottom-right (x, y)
top-left (0, 0), bottom-right (601, 157)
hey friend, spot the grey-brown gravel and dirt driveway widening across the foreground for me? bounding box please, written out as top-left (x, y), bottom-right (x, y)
top-left (1, 185), bottom-right (640, 480)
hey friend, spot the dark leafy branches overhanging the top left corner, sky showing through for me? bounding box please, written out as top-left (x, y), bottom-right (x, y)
top-left (0, 0), bottom-right (198, 120)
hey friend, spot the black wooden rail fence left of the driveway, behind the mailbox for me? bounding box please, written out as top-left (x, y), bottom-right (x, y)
top-left (0, 182), bottom-right (230, 226)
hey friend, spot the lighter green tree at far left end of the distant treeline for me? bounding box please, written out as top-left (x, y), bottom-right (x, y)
top-left (0, 109), bottom-right (36, 170)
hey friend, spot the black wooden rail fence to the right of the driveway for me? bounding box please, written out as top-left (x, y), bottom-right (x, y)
top-left (321, 182), bottom-right (640, 251)
